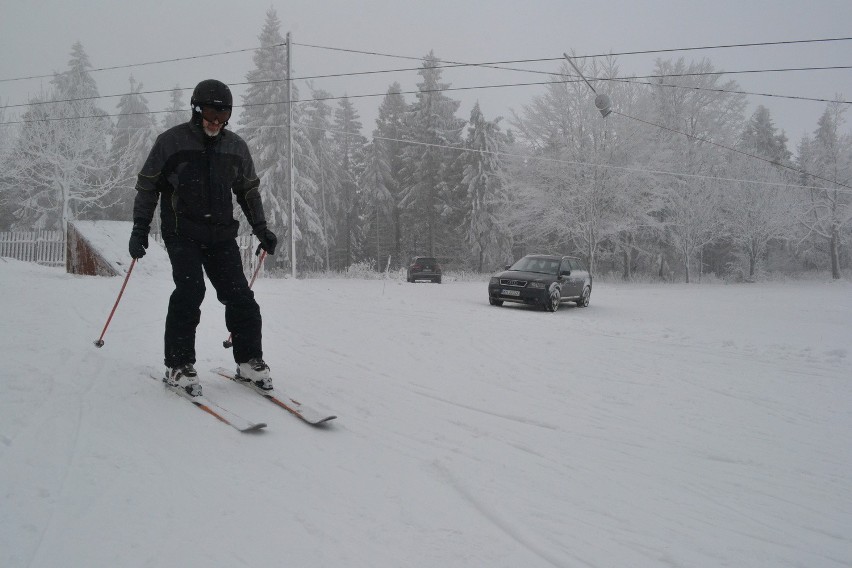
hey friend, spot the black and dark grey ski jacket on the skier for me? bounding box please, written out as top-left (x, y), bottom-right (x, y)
top-left (133, 121), bottom-right (266, 243)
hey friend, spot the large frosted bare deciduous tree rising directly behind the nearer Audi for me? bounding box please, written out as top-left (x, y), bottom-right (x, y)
top-left (509, 59), bottom-right (647, 271)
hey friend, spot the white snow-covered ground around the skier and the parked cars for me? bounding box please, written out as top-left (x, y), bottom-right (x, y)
top-left (0, 259), bottom-right (852, 568)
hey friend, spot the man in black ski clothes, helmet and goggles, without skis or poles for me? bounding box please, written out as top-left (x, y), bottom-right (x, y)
top-left (129, 79), bottom-right (278, 396)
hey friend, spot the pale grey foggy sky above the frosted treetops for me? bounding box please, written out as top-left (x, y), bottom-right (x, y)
top-left (0, 0), bottom-right (852, 148)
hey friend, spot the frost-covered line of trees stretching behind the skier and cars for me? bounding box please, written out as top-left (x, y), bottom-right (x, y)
top-left (0, 10), bottom-right (852, 282)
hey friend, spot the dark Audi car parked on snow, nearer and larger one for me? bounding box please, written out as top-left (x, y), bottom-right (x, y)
top-left (488, 254), bottom-right (592, 312)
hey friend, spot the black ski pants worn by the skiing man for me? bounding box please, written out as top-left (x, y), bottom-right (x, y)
top-left (165, 237), bottom-right (263, 367)
